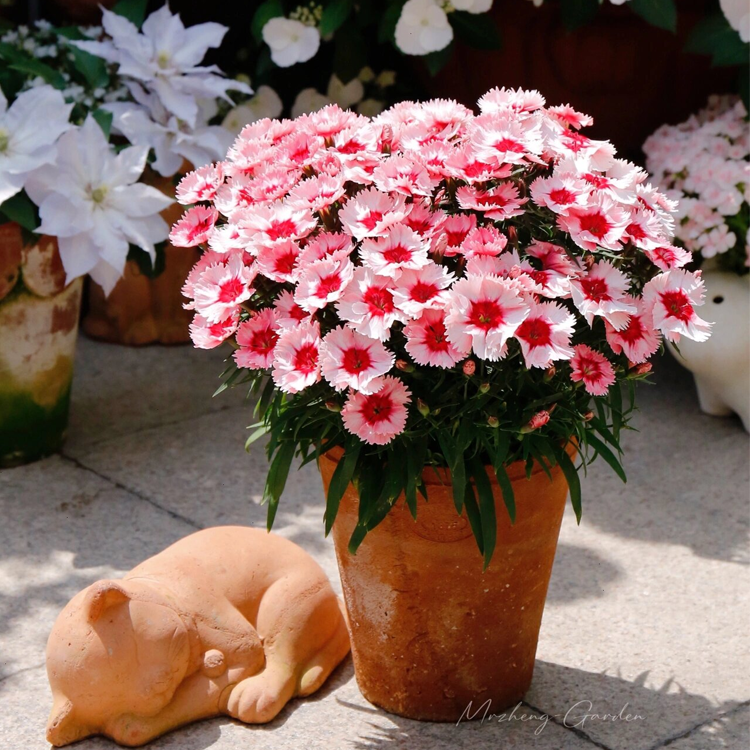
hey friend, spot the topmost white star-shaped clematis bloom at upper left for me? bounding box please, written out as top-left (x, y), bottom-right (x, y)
top-left (71, 5), bottom-right (252, 127)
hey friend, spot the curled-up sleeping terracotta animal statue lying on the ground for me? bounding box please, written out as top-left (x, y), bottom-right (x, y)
top-left (47, 526), bottom-right (349, 746)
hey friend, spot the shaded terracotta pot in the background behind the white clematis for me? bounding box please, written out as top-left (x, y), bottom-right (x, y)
top-left (83, 172), bottom-right (200, 346)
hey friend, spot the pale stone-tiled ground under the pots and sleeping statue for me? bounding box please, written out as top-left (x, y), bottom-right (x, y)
top-left (0, 340), bottom-right (750, 750)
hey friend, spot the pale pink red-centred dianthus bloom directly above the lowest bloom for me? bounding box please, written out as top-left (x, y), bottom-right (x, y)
top-left (320, 326), bottom-right (396, 393)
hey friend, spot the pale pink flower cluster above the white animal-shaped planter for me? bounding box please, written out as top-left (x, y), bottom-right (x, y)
top-left (643, 97), bottom-right (750, 258)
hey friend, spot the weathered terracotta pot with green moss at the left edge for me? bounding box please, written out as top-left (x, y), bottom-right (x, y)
top-left (0, 224), bottom-right (82, 467)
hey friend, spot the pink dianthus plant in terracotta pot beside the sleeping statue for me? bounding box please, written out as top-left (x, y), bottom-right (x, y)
top-left (172, 89), bottom-right (709, 721)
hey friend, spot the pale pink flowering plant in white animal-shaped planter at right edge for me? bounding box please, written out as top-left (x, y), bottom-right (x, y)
top-left (643, 96), bottom-right (750, 431)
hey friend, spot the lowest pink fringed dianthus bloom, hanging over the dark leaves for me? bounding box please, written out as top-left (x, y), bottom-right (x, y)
top-left (341, 375), bottom-right (411, 445)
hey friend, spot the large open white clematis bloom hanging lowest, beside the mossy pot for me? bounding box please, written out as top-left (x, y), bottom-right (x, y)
top-left (26, 117), bottom-right (174, 294)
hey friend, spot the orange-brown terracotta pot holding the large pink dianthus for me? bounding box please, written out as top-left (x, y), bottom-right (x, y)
top-left (320, 446), bottom-right (574, 721)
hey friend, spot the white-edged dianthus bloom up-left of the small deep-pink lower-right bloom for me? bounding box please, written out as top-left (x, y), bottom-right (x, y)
top-left (514, 302), bottom-right (576, 367)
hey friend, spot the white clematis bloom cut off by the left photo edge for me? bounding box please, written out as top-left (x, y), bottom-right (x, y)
top-left (0, 85), bottom-right (73, 203)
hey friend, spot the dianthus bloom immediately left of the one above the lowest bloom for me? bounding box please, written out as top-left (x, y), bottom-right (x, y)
top-left (271, 322), bottom-right (320, 393)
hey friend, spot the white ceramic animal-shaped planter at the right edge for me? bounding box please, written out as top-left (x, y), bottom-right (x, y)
top-left (670, 270), bottom-right (750, 432)
